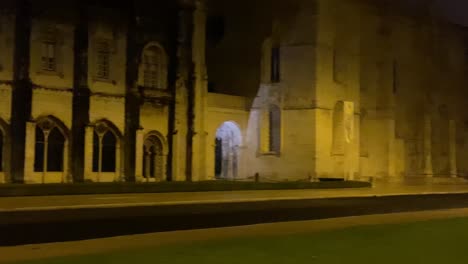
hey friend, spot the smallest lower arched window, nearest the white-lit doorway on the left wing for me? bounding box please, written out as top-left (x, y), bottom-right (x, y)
top-left (143, 135), bottom-right (165, 180)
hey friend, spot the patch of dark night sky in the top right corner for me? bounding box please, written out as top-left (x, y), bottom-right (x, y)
top-left (436, 0), bottom-right (468, 27)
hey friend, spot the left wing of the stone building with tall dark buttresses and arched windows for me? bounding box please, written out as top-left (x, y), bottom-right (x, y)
top-left (0, 0), bottom-right (206, 183)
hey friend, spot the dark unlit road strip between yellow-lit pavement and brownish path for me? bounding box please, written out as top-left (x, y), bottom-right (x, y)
top-left (0, 194), bottom-right (468, 246)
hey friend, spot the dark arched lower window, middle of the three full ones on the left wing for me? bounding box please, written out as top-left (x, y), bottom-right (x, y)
top-left (93, 123), bottom-right (117, 172)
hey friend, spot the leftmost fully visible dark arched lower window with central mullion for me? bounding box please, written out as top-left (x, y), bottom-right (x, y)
top-left (34, 119), bottom-right (65, 172)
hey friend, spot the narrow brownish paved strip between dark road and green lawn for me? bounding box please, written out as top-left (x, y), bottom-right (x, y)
top-left (0, 209), bottom-right (468, 263)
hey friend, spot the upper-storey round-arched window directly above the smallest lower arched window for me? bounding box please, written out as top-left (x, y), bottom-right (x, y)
top-left (140, 45), bottom-right (167, 89)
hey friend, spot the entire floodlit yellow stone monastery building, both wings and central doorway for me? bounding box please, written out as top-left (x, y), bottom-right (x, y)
top-left (0, 0), bottom-right (468, 183)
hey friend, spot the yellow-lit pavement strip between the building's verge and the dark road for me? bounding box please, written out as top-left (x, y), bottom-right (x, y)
top-left (0, 184), bottom-right (468, 212)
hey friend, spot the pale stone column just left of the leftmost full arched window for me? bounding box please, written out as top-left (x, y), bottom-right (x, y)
top-left (24, 122), bottom-right (38, 183)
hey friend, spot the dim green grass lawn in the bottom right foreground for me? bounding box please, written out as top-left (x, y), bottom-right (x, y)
top-left (11, 218), bottom-right (468, 264)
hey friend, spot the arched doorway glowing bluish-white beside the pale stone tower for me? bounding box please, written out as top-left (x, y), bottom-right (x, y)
top-left (215, 121), bottom-right (242, 179)
